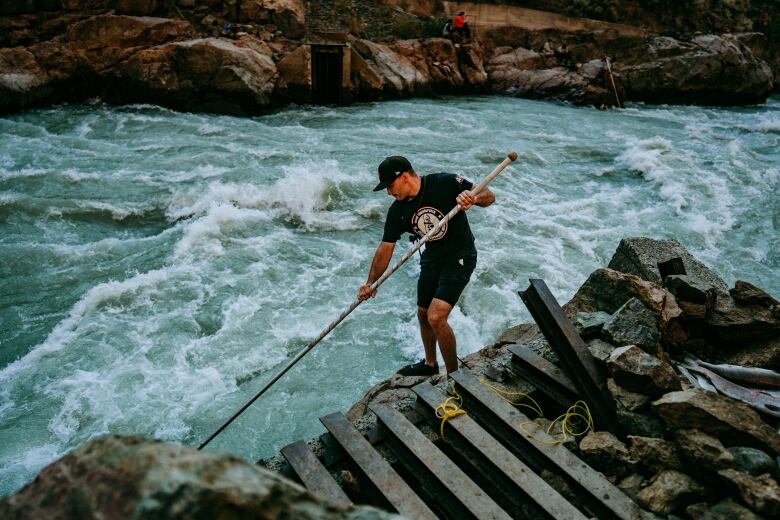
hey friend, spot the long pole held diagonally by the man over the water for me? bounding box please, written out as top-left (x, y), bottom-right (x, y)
top-left (198, 152), bottom-right (517, 450)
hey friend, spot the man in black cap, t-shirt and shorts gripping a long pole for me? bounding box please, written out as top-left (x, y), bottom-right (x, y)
top-left (358, 155), bottom-right (496, 376)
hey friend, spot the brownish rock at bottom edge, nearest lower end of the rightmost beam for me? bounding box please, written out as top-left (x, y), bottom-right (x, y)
top-left (636, 469), bottom-right (706, 515)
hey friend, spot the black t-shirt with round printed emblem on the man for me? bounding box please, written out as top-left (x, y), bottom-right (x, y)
top-left (382, 173), bottom-right (477, 264)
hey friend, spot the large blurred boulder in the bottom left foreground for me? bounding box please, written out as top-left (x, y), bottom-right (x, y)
top-left (0, 436), bottom-right (399, 520)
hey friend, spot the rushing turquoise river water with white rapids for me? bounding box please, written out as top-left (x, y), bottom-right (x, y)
top-left (0, 97), bottom-right (780, 494)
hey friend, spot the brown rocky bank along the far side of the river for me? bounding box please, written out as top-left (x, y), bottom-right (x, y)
top-left (0, 0), bottom-right (780, 114)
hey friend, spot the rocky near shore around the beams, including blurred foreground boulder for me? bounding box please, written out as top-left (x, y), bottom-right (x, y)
top-left (0, 238), bottom-right (780, 520)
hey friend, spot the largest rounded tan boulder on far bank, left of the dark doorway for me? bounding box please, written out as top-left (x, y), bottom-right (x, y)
top-left (119, 37), bottom-right (278, 114)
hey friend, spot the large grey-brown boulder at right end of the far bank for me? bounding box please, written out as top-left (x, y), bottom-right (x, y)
top-left (621, 34), bottom-right (773, 104)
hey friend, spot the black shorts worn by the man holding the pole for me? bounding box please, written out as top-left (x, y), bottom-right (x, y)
top-left (417, 255), bottom-right (477, 309)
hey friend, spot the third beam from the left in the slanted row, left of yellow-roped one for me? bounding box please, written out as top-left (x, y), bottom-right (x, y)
top-left (369, 405), bottom-right (511, 520)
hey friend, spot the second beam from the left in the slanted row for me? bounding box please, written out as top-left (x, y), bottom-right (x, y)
top-left (320, 412), bottom-right (436, 520)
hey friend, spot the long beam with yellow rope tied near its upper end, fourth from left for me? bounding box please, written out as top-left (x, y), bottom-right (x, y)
top-left (412, 381), bottom-right (586, 520)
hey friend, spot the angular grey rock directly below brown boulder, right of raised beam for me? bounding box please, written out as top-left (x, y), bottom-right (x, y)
top-left (601, 298), bottom-right (661, 354)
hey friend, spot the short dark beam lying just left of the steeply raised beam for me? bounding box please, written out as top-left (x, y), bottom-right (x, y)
top-left (508, 345), bottom-right (579, 410)
